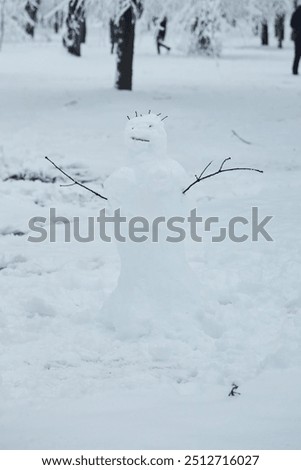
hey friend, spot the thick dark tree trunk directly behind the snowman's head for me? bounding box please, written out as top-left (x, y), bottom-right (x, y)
top-left (115, 7), bottom-right (135, 90)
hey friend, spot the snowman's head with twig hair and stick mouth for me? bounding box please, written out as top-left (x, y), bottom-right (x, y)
top-left (124, 112), bottom-right (167, 157)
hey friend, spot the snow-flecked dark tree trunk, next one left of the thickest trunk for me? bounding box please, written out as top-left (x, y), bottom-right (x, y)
top-left (63, 0), bottom-right (86, 57)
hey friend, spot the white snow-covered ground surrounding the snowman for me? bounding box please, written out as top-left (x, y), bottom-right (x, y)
top-left (0, 31), bottom-right (301, 449)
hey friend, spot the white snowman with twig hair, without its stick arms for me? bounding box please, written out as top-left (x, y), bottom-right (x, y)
top-left (103, 114), bottom-right (199, 335)
